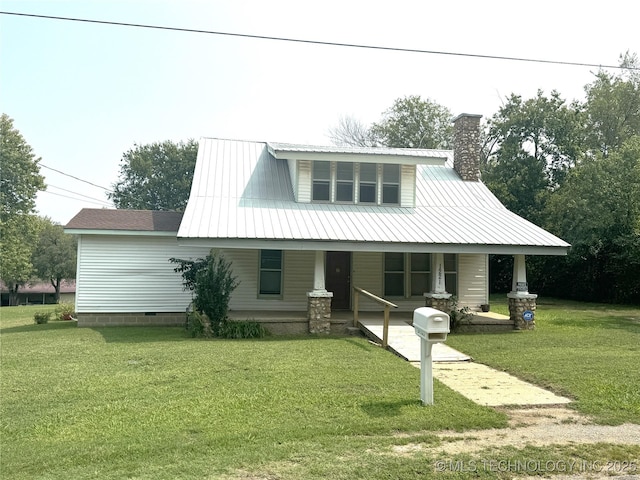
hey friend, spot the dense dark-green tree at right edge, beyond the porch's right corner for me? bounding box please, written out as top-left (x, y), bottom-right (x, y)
top-left (547, 135), bottom-right (640, 303)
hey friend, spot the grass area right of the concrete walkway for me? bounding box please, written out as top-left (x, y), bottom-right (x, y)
top-left (447, 298), bottom-right (640, 425)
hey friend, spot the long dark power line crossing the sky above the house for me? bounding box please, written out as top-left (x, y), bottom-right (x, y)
top-left (0, 11), bottom-right (640, 70)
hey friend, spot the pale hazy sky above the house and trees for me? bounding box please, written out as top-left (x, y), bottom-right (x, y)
top-left (0, 0), bottom-right (640, 225)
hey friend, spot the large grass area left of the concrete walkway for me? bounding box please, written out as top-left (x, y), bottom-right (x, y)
top-left (0, 307), bottom-right (506, 479)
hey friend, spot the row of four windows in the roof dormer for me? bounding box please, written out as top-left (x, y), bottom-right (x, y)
top-left (311, 161), bottom-right (400, 205)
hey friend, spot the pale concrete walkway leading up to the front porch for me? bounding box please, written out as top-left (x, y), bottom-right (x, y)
top-left (359, 319), bottom-right (571, 406)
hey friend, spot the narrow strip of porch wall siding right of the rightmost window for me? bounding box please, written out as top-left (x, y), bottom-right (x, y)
top-left (458, 253), bottom-right (489, 309)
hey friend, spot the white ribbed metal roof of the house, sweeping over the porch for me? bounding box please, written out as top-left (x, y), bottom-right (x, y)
top-left (178, 138), bottom-right (569, 255)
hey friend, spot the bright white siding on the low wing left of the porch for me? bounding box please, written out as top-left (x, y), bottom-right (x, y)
top-left (76, 235), bottom-right (209, 313)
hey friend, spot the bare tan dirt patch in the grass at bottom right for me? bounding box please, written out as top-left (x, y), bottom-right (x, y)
top-left (393, 406), bottom-right (640, 455)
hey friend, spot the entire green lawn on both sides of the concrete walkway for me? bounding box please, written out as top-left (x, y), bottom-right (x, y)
top-left (0, 303), bottom-right (640, 480)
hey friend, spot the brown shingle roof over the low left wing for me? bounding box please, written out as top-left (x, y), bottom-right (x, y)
top-left (65, 208), bottom-right (182, 234)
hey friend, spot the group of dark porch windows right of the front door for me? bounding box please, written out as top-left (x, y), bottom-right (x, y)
top-left (384, 252), bottom-right (458, 298)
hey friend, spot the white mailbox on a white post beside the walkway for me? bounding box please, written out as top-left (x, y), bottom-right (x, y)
top-left (413, 307), bottom-right (449, 405)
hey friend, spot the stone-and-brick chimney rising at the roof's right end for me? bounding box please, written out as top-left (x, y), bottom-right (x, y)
top-left (453, 113), bottom-right (482, 182)
